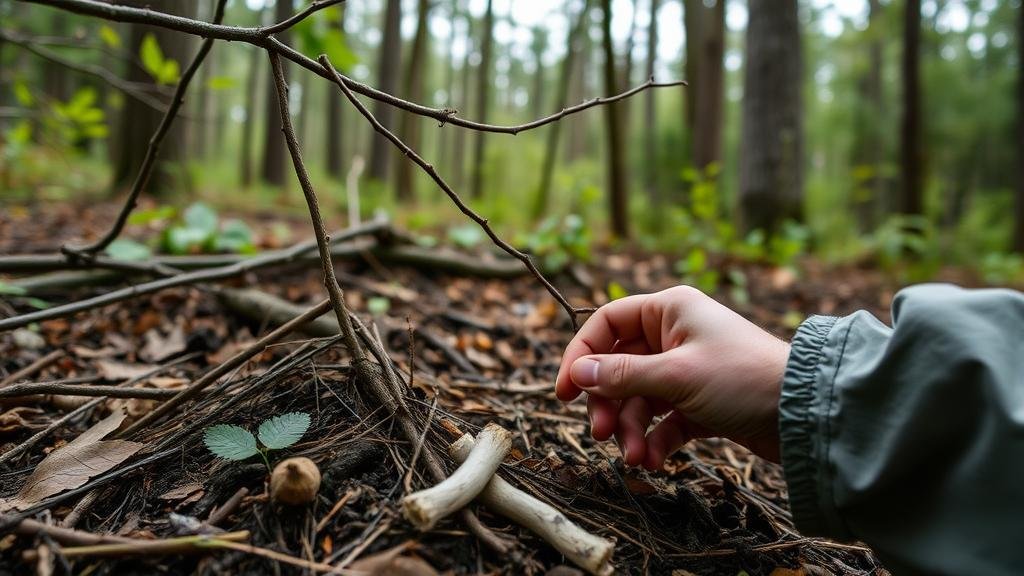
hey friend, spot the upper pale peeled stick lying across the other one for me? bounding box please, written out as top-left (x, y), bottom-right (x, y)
top-left (401, 423), bottom-right (512, 530)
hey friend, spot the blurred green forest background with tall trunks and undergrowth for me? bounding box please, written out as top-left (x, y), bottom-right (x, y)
top-left (0, 0), bottom-right (1024, 288)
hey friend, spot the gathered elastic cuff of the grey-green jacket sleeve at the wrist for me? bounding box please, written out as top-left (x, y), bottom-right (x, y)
top-left (778, 316), bottom-right (839, 536)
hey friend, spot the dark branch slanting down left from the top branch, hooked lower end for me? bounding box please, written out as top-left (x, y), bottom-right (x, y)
top-left (60, 0), bottom-right (227, 258)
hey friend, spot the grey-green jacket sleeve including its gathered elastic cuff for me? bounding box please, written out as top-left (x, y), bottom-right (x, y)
top-left (779, 284), bottom-right (1024, 574)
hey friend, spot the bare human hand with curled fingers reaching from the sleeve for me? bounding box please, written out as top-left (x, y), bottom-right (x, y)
top-left (555, 286), bottom-right (790, 469)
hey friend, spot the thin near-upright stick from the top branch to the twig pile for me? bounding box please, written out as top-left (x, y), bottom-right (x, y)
top-left (267, 51), bottom-right (366, 363)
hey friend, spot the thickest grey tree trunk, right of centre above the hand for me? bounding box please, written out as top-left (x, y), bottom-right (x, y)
top-left (739, 0), bottom-right (803, 233)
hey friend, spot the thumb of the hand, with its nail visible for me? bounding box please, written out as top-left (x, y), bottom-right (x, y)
top-left (569, 351), bottom-right (681, 402)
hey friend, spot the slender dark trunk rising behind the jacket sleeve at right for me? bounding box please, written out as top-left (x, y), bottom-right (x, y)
top-left (900, 0), bottom-right (925, 214)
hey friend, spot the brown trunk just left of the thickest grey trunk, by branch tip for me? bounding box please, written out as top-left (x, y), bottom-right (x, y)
top-left (691, 0), bottom-right (724, 171)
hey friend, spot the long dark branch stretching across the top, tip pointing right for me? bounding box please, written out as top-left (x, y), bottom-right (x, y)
top-left (20, 0), bottom-right (687, 134)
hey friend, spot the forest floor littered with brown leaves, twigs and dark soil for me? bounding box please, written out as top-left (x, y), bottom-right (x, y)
top-left (0, 199), bottom-right (929, 575)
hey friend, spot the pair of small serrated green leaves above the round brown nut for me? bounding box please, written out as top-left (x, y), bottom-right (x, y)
top-left (203, 412), bottom-right (309, 470)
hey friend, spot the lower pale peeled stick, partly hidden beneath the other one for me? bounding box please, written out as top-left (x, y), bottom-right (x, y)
top-left (449, 434), bottom-right (615, 576)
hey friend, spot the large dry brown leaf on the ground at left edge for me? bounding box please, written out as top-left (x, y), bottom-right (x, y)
top-left (0, 411), bottom-right (142, 510)
